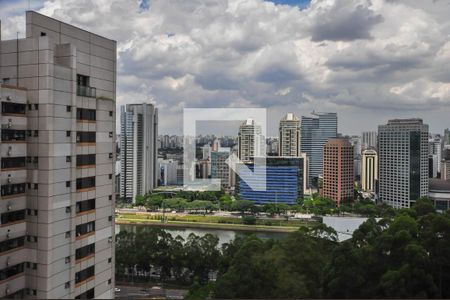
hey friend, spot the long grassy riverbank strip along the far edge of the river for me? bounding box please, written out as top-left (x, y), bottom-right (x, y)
top-left (116, 214), bottom-right (312, 233)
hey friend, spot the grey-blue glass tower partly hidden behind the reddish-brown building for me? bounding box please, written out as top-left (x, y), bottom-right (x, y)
top-left (300, 112), bottom-right (337, 184)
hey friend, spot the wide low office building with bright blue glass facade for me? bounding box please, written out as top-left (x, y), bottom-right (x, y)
top-left (236, 157), bottom-right (304, 205)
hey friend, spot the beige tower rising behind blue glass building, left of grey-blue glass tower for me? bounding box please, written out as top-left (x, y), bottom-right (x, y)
top-left (278, 113), bottom-right (300, 157)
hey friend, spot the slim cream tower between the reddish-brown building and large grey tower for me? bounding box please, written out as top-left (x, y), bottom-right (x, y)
top-left (361, 148), bottom-right (378, 193)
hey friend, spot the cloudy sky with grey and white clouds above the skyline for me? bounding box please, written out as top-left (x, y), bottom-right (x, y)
top-left (0, 0), bottom-right (450, 135)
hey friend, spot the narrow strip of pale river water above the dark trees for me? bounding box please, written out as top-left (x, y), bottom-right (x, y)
top-left (116, 225), bottom-right (288, 245)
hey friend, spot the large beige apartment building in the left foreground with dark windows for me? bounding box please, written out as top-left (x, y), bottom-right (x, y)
top-left (0, 11), bottom-right (116, 299)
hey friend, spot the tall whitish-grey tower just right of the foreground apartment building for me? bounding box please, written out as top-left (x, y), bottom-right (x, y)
top-left (120, 103), bottom-right (160, 202)
